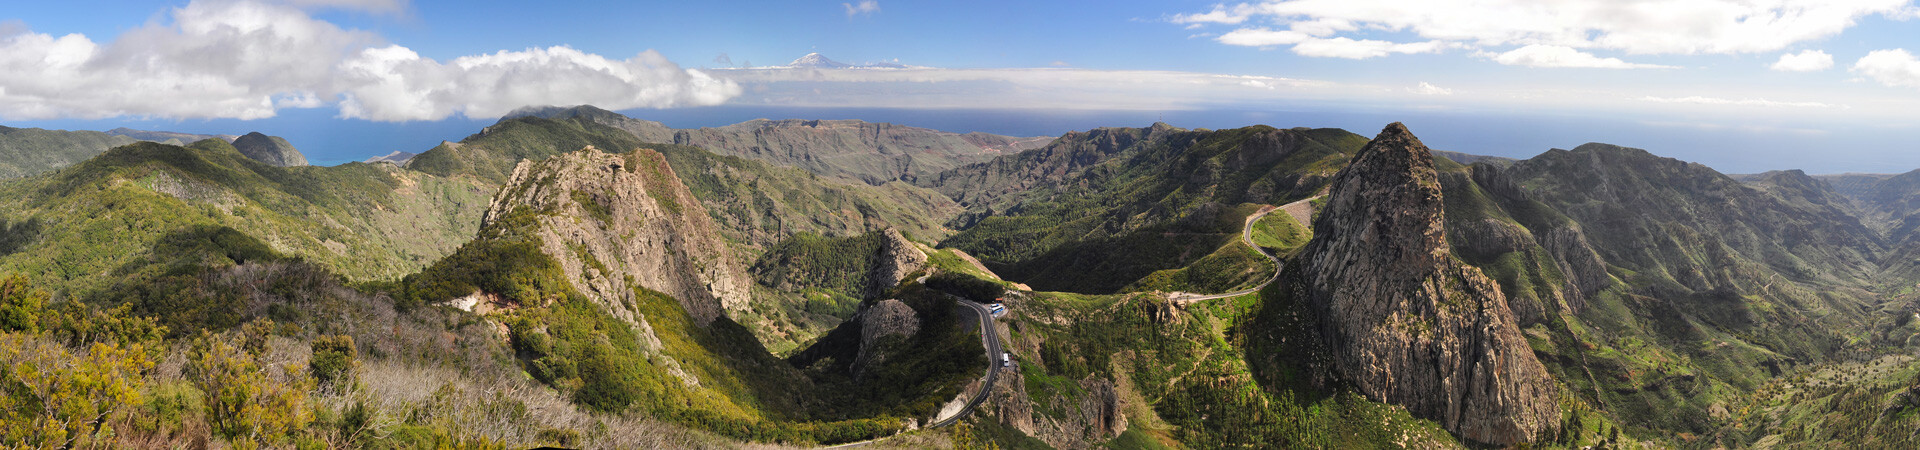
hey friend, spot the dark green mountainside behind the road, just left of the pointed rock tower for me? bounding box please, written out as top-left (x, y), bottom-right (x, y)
top-left (935, 127), bottom-right (1365, 292)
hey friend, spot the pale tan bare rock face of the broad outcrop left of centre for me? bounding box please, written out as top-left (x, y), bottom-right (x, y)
top-left (482, 146), bottom-right (753, 325)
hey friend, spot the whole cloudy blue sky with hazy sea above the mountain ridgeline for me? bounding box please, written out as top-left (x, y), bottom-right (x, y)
top-left (0, 0), bottom-right (1920, 173)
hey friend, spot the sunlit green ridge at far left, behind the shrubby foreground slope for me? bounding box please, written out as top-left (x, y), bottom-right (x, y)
top-left (0, 140), bottom-right (486, 292)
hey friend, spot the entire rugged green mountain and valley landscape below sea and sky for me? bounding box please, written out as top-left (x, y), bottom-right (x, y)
top-left (0, 106), bottom-right (1920, 448)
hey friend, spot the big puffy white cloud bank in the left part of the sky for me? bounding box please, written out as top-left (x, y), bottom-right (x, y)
top-left (0, 0), bottom-right (739, 121)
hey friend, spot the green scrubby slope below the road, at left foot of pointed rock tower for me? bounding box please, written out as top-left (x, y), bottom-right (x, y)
top-left (1006, 280), bottom-right (1457, 448)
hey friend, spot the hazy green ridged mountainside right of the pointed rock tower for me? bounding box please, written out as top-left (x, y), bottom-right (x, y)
top-left (1442, 144), bottom-right (1905, 437)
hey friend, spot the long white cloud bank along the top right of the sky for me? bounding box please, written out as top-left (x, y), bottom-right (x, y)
top-left (1169, 0), bottom-right (1914, 62)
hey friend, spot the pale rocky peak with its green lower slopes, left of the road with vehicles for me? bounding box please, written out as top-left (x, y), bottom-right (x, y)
top-left (397, 148), bottom-right (985, 442)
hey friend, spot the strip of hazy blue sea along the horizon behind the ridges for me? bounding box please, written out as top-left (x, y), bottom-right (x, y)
top-left (6, 104), bottom-right (1889, 175)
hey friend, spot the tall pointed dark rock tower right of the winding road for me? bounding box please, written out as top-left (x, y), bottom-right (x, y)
top-left (1284, 123), bottom-right (1559, 446)
